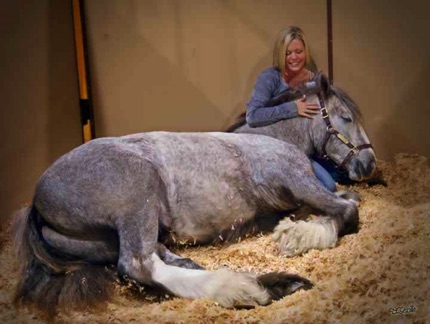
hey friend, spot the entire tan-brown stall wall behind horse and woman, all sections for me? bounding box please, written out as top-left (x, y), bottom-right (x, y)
top-left (0, 0), bottom-right (430, 223)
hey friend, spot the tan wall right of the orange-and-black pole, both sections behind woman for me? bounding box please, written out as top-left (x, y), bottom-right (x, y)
top-left (86, 0), bottom-right (430, 160)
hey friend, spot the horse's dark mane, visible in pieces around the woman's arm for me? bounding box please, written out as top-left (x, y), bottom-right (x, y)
top-left (226, 74), bottom-right (362, 133)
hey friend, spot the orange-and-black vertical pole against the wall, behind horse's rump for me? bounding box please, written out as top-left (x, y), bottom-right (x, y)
top-left (72, 0), bottom-right (95, 143)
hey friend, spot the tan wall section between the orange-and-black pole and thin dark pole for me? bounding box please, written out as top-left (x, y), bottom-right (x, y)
top-left (86, 0), bottom-right (327, 136)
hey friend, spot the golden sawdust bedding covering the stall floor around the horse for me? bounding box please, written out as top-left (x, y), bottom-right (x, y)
top-left (0, 154), bottom-right (430, 323)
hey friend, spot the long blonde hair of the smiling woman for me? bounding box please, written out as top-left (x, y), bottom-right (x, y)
top-left (273, 26), bottom-right (311, 74)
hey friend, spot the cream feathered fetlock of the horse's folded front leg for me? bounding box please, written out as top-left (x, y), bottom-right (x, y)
top-left (273, 217), bottom-right (337, 256)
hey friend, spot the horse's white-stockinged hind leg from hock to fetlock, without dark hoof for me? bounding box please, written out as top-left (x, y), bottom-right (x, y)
top-left (118, 204), bottom-right (271, 307)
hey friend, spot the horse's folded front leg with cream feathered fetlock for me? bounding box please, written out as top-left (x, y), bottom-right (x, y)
top-left (273, 185), bottom-right (358, 256)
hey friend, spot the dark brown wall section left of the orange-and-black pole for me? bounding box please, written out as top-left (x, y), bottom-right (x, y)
top-left (0, 0), bottom-right (81, 227)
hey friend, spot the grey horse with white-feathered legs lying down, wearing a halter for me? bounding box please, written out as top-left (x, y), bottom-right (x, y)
top-left (14, 76), bottom-right (376, 317)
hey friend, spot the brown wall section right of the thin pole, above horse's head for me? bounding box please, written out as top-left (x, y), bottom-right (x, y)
top-left (333, 0), bottom-right (430, 160)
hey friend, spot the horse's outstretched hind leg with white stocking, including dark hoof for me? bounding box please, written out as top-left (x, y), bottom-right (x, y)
top-left (116, 165), bottom-right (308, 307)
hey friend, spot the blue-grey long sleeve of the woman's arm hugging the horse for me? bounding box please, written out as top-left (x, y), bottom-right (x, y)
top-left (246, 69), bottom-right (298, 127)
